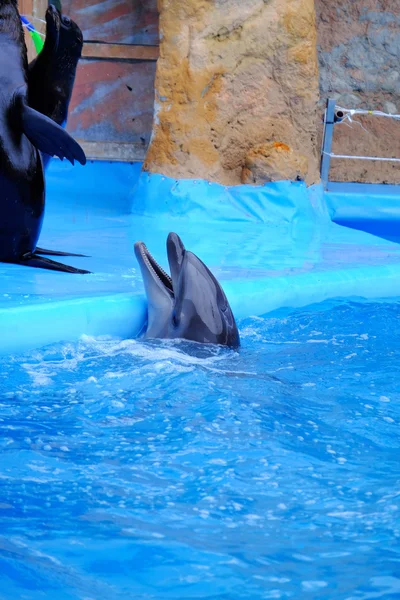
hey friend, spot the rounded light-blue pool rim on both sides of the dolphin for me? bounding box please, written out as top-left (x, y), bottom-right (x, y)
top-left (0, 265), bottom-right (400, 355)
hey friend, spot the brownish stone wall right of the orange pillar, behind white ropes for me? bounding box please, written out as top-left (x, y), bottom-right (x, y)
top-left (315, 0), bottom-right (400, 183)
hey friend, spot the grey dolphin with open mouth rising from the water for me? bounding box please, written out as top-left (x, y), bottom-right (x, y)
top-left (135, 233), bottom-right (240, 348)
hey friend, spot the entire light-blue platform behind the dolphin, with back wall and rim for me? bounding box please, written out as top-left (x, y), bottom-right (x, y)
top-left (0, 160), bottom-right (400, 354)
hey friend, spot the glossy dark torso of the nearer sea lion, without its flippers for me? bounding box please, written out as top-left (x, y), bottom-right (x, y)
top-left (0, 2), bottom-right (44, 261)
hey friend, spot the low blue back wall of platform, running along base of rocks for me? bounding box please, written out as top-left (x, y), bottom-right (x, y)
top-left (46, 159), bottom-right (400, 237)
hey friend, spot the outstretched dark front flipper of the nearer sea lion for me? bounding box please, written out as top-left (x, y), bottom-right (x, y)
top-left (21, 102), bottom-right (86, 165)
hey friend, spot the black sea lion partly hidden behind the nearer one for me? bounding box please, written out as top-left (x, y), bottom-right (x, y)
top-left (28, 5), bottom-right (83, 167)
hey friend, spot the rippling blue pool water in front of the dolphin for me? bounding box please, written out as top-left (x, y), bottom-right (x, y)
top-left (0, 302), bottom-right (400, 600)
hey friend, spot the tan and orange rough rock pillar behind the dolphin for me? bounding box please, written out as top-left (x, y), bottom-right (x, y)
top-left (145, 0), bottom-right (319, 184)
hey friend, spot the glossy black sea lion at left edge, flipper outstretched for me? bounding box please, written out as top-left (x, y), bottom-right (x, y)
top-left (0, 0), bottom-right (87, 273)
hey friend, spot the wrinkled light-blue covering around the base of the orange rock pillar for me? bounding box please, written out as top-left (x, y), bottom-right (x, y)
top-left (132, 172), bottom-right (328, 227)
